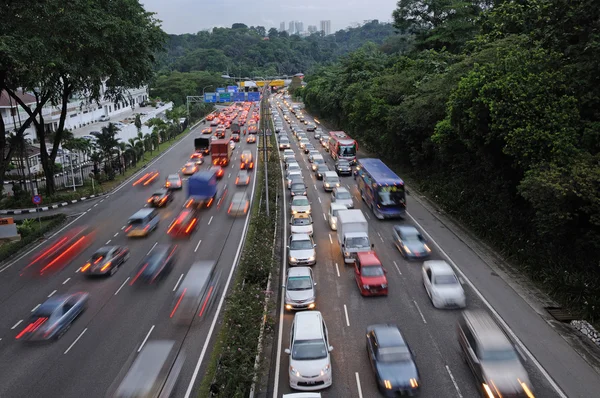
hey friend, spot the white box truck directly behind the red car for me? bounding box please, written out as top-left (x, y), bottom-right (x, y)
top-left (337, 209), bottom-right (375, 264)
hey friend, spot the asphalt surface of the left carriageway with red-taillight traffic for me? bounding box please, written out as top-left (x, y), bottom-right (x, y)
top-left (0, 110), bottom-right (257, 398)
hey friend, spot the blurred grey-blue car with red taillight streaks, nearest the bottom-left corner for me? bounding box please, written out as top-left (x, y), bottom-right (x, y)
top-left (15, 292), bottom-right (89, 341)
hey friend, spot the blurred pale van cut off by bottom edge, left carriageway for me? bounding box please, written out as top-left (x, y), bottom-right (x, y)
top-left (113, 340), bottom-right (185, 398)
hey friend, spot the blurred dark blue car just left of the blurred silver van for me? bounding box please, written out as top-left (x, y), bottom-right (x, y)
top-left (129, 244), bottom-right (177, 286)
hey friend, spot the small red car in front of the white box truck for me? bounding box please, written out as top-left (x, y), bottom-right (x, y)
top-left (354, 251), bottom-right (388, 296)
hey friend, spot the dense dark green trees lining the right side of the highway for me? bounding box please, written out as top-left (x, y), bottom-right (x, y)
top-left (301, 0), bottom-right (600, 321)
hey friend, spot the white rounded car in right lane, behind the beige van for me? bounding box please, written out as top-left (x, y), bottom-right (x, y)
top-left (422, 260), bottom-right (467, 308)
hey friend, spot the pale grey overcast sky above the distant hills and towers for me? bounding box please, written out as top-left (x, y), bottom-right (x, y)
top-left (140, 0), bottom-right (396, 34)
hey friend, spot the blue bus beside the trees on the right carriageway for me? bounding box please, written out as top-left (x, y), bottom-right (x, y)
top-left (354, 159), bottom-right (406, 220)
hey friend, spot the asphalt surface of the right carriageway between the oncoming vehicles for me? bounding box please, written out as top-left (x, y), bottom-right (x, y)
top-left (268, 96), bottom-right (600, 398)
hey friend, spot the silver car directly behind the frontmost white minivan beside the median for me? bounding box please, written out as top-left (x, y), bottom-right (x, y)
top-left (285, 267), bottom-right (317, 311)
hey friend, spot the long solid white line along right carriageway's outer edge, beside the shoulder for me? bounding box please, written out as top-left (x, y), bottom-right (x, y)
top-left (406, 212), bottom-right (568, 398)
